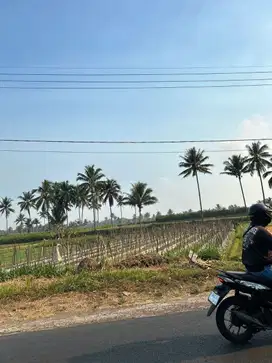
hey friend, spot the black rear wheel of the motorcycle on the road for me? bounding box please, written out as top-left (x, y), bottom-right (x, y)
top-left (216, 296), bottom-right (254, 345)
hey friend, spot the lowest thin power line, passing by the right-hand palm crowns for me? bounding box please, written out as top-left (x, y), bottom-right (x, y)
top-left (0, 149), bottom-right (252, 154)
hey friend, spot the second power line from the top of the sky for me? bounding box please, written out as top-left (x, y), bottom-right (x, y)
top-left (0, 70), bottom-right (272, 77)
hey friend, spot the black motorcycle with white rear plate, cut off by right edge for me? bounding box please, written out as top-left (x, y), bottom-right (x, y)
top-left (207, 270), bottom-right (272, 344)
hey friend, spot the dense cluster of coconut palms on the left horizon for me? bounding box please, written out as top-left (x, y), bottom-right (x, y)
top-left (0, 165), bottom-right (158, 231)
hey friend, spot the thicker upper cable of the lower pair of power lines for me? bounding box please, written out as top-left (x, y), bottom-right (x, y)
top-left (0, 137), bottom-right (272, 144)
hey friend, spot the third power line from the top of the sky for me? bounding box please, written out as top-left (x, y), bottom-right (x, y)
top-left (0, 78), bottom-right (272, 84)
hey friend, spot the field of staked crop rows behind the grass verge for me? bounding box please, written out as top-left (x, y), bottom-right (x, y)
top-left (0, 221), bottom-right (233, 268)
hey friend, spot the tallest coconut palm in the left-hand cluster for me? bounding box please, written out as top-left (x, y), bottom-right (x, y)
top-left (77, 165), bottom-right (104, 226)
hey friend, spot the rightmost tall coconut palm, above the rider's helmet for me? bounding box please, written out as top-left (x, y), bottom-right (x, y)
top-left (246, 141), bottom-right (272, 201)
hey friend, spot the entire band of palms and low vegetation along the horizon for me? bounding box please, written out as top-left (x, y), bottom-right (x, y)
top-left (0, 142), bottom-right (272, 235)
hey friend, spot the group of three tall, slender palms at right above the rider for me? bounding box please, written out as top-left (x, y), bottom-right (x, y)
top-left (179, 141), bottom-right (272, 220)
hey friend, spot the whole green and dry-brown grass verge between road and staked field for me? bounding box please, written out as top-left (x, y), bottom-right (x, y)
top-left (0, 249), bottom-right (243, 327)
